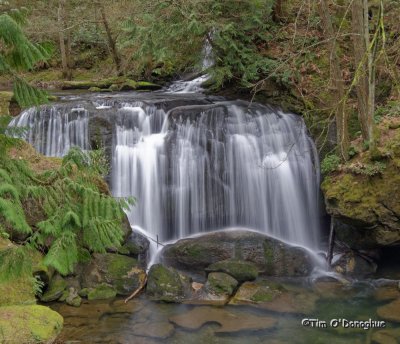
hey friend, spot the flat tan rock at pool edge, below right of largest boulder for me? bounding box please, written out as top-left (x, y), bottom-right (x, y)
top-left (229, 280), bottom-right (318, 314)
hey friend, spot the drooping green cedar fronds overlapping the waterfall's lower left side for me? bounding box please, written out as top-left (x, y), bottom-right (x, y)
top-left (0, 144), bottom-right (133, 275)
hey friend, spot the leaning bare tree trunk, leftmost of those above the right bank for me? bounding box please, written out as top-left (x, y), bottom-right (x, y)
top-left (318, 0), bottom-right (349, 160)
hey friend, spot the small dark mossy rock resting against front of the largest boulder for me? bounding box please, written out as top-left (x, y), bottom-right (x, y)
top-left (206, 259), bottom-right (258, 282)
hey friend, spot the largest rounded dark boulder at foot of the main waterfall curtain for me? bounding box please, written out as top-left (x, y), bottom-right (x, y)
top-left (161, 229), bottom-right (313, 278)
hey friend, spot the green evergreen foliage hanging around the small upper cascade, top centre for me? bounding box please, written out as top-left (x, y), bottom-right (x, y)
top-left (123, 0), bottom-right (280, 87)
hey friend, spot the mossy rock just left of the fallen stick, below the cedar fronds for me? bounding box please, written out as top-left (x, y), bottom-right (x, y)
top-left (80, 253), bottom-right (146, 295)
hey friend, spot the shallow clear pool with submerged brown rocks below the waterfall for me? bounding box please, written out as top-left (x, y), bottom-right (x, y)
top-left (52, 281), bottom-right (400, 344)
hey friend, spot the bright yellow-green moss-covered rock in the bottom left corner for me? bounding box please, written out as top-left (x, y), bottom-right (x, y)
top-left (0, 305), bottom-right (64, 343)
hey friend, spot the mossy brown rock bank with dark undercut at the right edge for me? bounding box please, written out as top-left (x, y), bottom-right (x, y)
top-left (322, 117), bottom-right (400, 249)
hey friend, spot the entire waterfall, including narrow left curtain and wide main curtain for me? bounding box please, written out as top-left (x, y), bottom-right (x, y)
top-left (11, 94), bottom-right (319, 248)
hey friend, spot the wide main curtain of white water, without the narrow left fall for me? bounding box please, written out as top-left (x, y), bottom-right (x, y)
top-left (112, 103), bottom-right (319, 247)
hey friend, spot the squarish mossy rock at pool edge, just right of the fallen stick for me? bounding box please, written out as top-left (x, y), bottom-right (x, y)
top-left (146, 264), bottom-right (191, 302)
